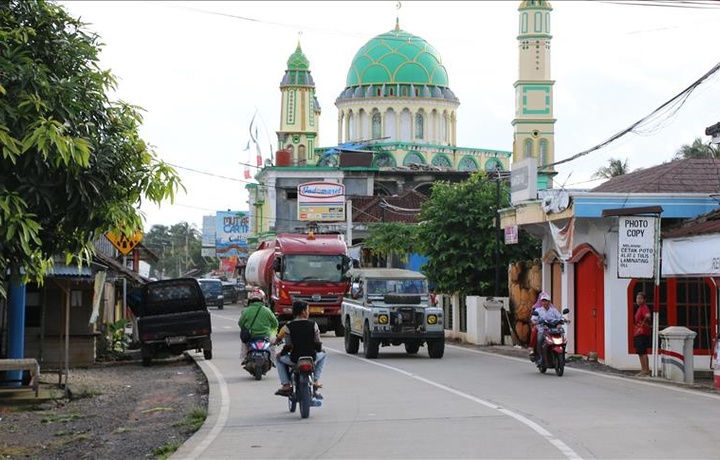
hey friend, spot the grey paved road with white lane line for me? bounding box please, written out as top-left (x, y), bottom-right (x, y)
top-left (172, 305), bottom-right (720, 459)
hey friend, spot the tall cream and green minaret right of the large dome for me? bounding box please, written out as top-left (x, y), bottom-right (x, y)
top-left (512, 0), bottom-right (557, 190)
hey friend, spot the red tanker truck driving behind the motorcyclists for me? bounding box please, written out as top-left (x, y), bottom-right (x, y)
top-left (245, 232), bottom-right (357, 337)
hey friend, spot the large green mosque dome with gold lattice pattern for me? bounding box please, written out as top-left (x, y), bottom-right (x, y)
top-left (346, 22), bottom-right (448, 88)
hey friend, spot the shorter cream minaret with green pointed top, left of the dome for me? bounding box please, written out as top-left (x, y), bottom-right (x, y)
top-left (276, 41), bottom-right (320, 166)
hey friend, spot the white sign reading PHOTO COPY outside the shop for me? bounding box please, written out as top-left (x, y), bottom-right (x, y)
top-left (618, 216), bottom-right (656, 278)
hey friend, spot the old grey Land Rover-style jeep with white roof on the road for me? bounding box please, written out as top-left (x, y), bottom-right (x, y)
top-left (341, 268), bottom-right (445, 359)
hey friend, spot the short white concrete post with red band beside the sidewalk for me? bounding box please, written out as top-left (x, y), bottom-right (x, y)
top-left (658, 326), bottom-right (697, 383)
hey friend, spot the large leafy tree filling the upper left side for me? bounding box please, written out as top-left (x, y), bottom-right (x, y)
top-left (0, 0), bottom-right (182, 297)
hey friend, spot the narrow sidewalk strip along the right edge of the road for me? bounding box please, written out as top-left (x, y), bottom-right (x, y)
top-left (464, 342), bottom-right (720, 394)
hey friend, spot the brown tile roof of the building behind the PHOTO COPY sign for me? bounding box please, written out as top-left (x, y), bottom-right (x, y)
top-left (590, 158), bottom-right (720, 194)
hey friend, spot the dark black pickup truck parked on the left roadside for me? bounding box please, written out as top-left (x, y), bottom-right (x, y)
top-left (128, 278), bottom-right (212, 366)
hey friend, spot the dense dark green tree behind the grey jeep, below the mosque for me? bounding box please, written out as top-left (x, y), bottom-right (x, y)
top-left (416, 172), bottom-right (540, 295)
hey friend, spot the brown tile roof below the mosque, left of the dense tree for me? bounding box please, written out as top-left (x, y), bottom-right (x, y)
top-left (348, 190), bottom-right (428, 224)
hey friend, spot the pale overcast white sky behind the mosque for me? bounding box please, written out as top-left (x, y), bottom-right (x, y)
top-left (59, 1), bottom-right (720, 231)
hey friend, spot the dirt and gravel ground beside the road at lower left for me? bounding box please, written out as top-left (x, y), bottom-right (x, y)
top-left (0, 356), bottom-right (208, 459)
